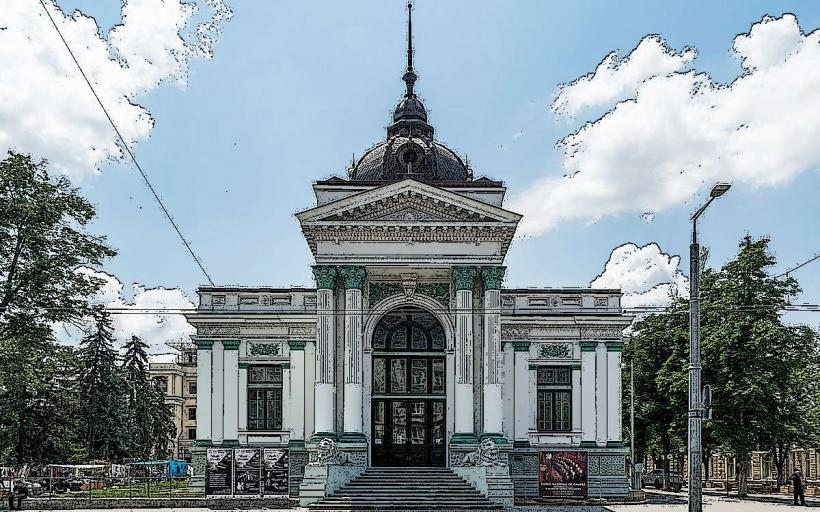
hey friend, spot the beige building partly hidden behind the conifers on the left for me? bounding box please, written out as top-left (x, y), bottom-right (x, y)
top-left (148, 343), bottom-right (197, 462)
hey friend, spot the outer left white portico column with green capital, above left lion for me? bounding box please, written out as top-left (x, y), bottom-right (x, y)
top-left (313, 265), bottom-right (336, 436)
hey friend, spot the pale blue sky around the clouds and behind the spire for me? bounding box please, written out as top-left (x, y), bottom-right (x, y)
top-left (43, 0), bottom-right (820, 326)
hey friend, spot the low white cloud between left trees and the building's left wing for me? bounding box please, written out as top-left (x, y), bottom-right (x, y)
top-left (54, 267), bottom-right (195, 360)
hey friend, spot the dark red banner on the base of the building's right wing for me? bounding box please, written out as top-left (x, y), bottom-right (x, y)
top-left (538, 452), bottom-right (588, 498)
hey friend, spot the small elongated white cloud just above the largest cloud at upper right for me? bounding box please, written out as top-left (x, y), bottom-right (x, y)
top-left (551, 35), bottom-right (697, 116)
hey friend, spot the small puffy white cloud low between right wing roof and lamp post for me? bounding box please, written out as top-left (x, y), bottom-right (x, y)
top-left (589, 243), bottom-right (689, 308)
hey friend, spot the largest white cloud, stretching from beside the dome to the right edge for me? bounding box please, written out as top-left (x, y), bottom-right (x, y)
top-left (512, 14), bottom-right (820, 236)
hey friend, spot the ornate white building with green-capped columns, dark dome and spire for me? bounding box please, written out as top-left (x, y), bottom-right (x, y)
top-left (188, 6), bottom-right (631, 503)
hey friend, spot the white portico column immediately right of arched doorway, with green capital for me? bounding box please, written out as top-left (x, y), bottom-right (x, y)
top-left (452, 267), bottom-right (478, 442)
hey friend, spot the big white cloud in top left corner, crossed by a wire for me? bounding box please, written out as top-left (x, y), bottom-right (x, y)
top-left (0, 0), bottom-right (231, 179)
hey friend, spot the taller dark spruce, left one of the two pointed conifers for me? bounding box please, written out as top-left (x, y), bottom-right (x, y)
top-left (77, 307), bottom-right (128, 460)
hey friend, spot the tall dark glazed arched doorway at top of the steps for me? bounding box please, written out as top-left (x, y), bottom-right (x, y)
top-left (370, 307), bottom-right (447, 466)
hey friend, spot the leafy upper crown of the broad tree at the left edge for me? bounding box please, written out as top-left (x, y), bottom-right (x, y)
top-left (0, 152), bottom-right (115, 338)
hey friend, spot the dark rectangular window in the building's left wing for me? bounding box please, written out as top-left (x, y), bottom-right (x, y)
top-left (248, 366), bottom-right (282, 430)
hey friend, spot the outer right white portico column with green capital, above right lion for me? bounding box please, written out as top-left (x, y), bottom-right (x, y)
top-left (481, 267), bottom-right (505, 437)
